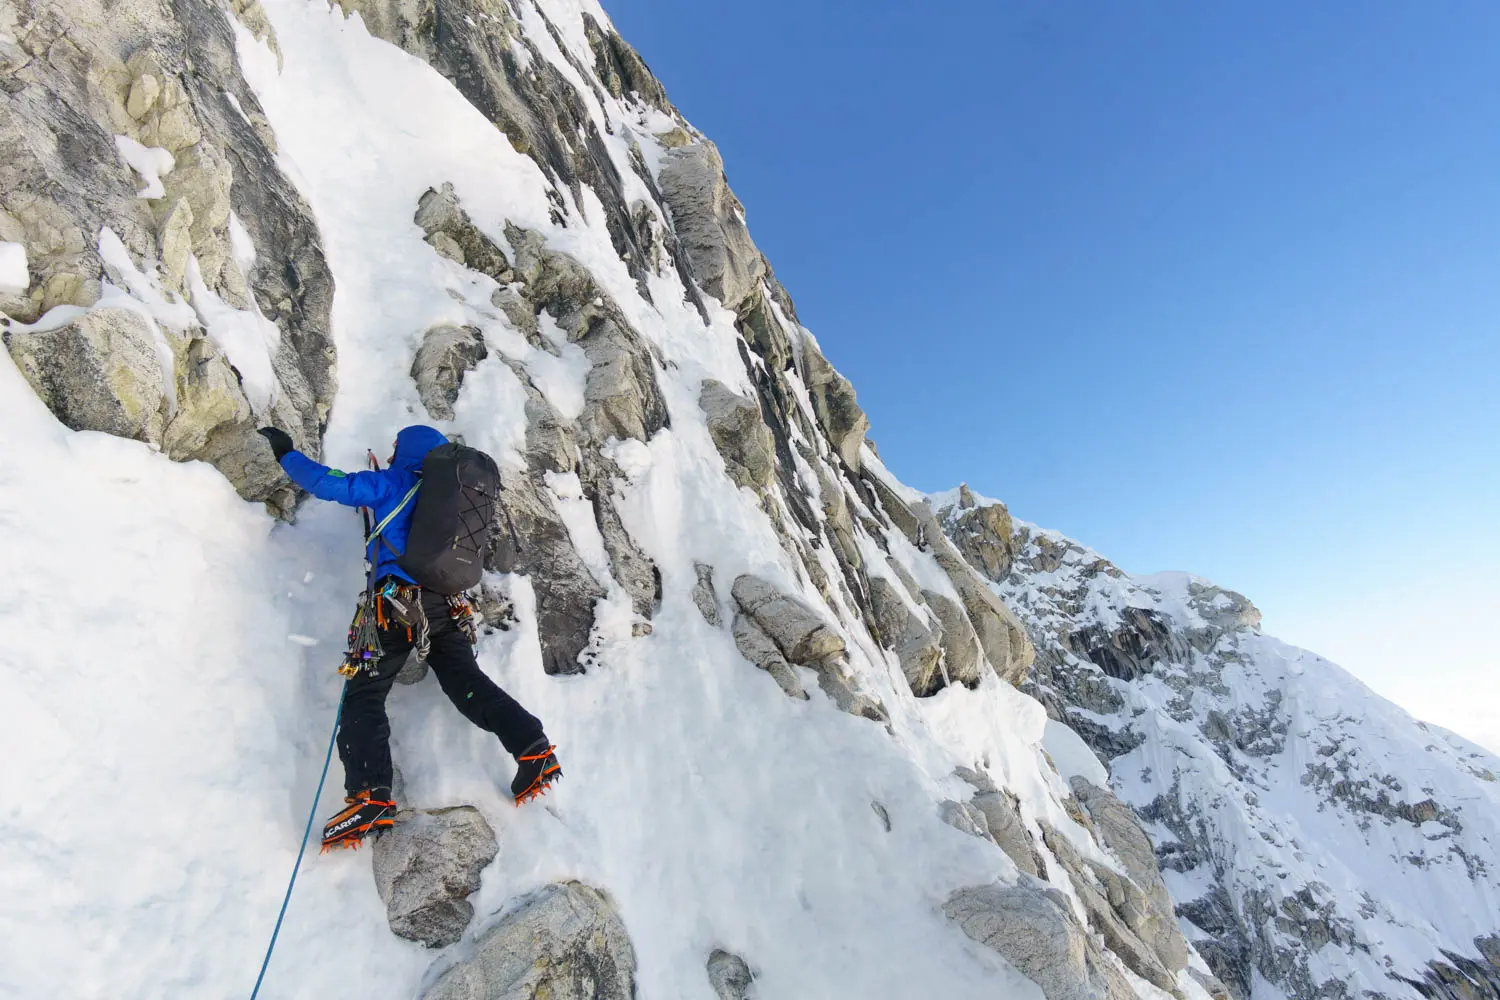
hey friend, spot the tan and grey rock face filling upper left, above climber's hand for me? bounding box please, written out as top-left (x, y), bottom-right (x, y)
top-left (0, 0), bottom-right (335, 511)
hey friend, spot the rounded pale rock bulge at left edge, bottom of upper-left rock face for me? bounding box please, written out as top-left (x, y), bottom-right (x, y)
top-left (6, 309), bottom-right (165, 442)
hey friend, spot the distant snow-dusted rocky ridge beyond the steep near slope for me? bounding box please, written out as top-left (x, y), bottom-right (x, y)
top-left (933, 489), bottom-right (1500, 997)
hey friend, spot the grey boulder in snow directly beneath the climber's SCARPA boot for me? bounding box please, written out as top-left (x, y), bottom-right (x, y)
top-left (372, 805), bottom-right (500, 948)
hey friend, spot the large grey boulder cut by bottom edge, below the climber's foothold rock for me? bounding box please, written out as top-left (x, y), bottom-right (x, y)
top-left (422, 882), bottom-right (636, 1000)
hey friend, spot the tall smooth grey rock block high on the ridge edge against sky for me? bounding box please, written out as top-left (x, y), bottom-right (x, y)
top-left (657, 139), bottom-right (767, 309)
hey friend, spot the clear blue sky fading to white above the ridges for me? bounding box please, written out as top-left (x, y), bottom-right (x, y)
top-left (606, 0), bottom-right (1500, 750)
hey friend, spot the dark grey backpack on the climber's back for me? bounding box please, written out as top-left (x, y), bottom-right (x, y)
top-left (396, 444), bottom-right (500, 594)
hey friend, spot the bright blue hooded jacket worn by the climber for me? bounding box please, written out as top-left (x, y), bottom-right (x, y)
top-left (282, 424), bottom-right (449, 583)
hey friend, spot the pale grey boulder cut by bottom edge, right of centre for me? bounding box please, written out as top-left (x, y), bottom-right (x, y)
top-left (944, 880), bottom-right (1136, 1000)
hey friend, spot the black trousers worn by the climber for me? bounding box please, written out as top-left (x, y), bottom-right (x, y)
top-left (339, 591), bottom-right (543, 795)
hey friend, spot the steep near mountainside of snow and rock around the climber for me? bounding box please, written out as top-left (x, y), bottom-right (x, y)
top-left (0, 0), bottom-right (1493, 1000)
